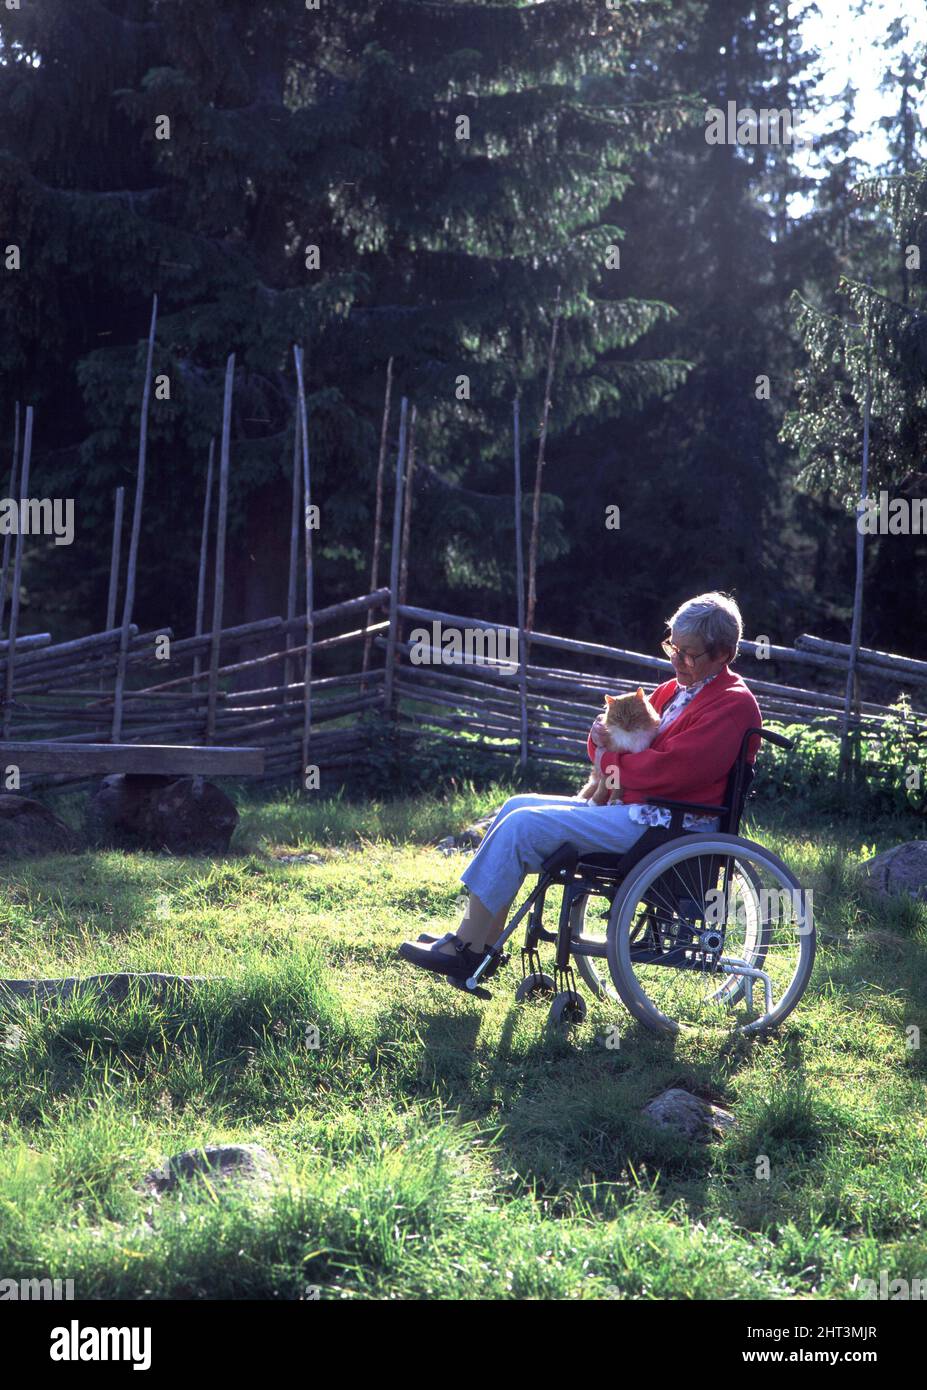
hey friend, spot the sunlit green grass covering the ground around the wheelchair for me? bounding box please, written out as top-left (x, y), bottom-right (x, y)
top-left (0, 787), bottom-right (927, 1298)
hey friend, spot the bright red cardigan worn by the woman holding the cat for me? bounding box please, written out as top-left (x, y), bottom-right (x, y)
top-left (586, 666), bottom-right (763, 806)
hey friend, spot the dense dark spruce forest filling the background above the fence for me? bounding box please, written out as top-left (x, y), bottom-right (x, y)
top-left (0, 0), bottom-right (927, 656)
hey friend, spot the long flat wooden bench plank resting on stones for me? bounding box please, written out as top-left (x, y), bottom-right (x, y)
top-left (0, 738), bottom-right (264, 777)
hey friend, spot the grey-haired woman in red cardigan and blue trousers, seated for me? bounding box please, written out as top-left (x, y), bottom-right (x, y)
top-left (399, 594), bottom-right (762, 980)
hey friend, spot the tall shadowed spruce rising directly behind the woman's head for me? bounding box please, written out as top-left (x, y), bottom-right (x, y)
top-left (544, 0), bottom-right (830, 649)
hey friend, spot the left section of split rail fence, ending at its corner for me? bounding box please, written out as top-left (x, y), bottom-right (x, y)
top-left (0, 589), bottom-right (389, 790)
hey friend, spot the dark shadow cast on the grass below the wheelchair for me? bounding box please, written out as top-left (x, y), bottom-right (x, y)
top-left (381, 961), bottom-right (867, 1225)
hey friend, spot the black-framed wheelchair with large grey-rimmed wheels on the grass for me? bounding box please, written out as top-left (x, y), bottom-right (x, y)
top-left (460, 728), bottom-right (816, 1034)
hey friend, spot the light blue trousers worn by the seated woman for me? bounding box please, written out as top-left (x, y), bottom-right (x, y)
top-left (460, 792), bottom-right (646, 916)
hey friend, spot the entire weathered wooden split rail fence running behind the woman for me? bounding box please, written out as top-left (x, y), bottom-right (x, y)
top-left (0, 588), bottom-right (927, 787)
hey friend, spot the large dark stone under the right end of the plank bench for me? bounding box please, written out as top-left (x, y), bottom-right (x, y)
top-left (86, 773), bottom-right (238, 855)
